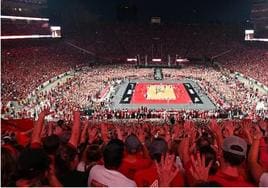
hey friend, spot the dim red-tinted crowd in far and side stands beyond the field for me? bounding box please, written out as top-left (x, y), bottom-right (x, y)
top-left (1, 24), bottom-right (268, 105)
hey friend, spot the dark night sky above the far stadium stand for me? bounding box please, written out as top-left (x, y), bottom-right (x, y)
top-left (48, 0), bottom-right (251, 23)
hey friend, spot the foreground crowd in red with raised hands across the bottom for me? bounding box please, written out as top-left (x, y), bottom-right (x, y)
top-left (1, 109), bottom-right (268, 187)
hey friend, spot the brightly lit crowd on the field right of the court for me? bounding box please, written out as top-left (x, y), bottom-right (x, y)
top-left (164, 66), bottom-right (268, 118)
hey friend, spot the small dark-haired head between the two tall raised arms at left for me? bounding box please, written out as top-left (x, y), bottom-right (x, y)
top-left (43, 135), bottom-right (60, 154)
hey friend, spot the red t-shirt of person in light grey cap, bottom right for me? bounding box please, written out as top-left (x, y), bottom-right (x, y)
top-left (209, 170), bottom-right (254, 187)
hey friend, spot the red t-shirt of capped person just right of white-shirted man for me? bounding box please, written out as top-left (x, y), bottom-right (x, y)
top-left (118, 155), bottom-right (152, 180)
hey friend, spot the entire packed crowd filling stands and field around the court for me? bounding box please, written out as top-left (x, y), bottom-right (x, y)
top-left (1, 25), bottom-right (268, 187)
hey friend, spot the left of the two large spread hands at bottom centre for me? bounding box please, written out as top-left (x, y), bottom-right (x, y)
top-left (155, 154), bottom-right (179, 187)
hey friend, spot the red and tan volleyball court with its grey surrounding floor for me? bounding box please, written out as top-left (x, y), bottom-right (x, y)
top-left (109, 79), bottom-right (216, 110)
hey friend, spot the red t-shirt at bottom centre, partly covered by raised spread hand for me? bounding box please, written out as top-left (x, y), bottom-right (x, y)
top-left (134, 163), bottom-right (184, 187)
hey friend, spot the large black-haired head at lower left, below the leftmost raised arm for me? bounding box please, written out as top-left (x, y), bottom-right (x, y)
top-left (17, 148), bottom-right (50, 180)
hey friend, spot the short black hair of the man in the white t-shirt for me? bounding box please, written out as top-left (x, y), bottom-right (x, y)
top-left (103, 139), bottom-right (124, 169)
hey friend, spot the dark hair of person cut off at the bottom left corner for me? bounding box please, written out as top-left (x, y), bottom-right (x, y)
top-left (1, 147), bottom-right (16, 187)
